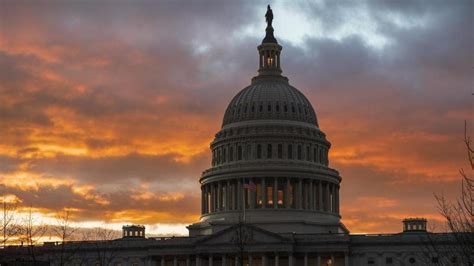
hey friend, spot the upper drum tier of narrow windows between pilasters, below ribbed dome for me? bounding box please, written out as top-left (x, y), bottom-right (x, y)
top-left (212, 143), bottom-right (328, 166)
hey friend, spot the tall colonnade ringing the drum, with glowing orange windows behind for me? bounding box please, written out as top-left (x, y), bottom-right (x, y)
top-left (201, 177), bottom-right (339, 214)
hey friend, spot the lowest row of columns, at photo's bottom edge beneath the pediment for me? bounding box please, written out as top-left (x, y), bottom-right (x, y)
top-left (160, 253), bottom-right (349, 266)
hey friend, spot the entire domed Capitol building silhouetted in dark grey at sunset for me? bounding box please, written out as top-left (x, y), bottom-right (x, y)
top-left (0, 5), bottom-right (461, 266)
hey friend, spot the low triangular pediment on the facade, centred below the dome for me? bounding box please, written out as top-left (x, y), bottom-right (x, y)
top-left (199, 224), bottom-right (289, 245)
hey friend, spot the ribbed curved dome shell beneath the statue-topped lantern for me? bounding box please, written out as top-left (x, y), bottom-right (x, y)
top-left (222, 76), bottom-right (318, 126)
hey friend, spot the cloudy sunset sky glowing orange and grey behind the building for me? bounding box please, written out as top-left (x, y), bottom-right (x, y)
top-left (0, 0), bottom-right (474, 237)
